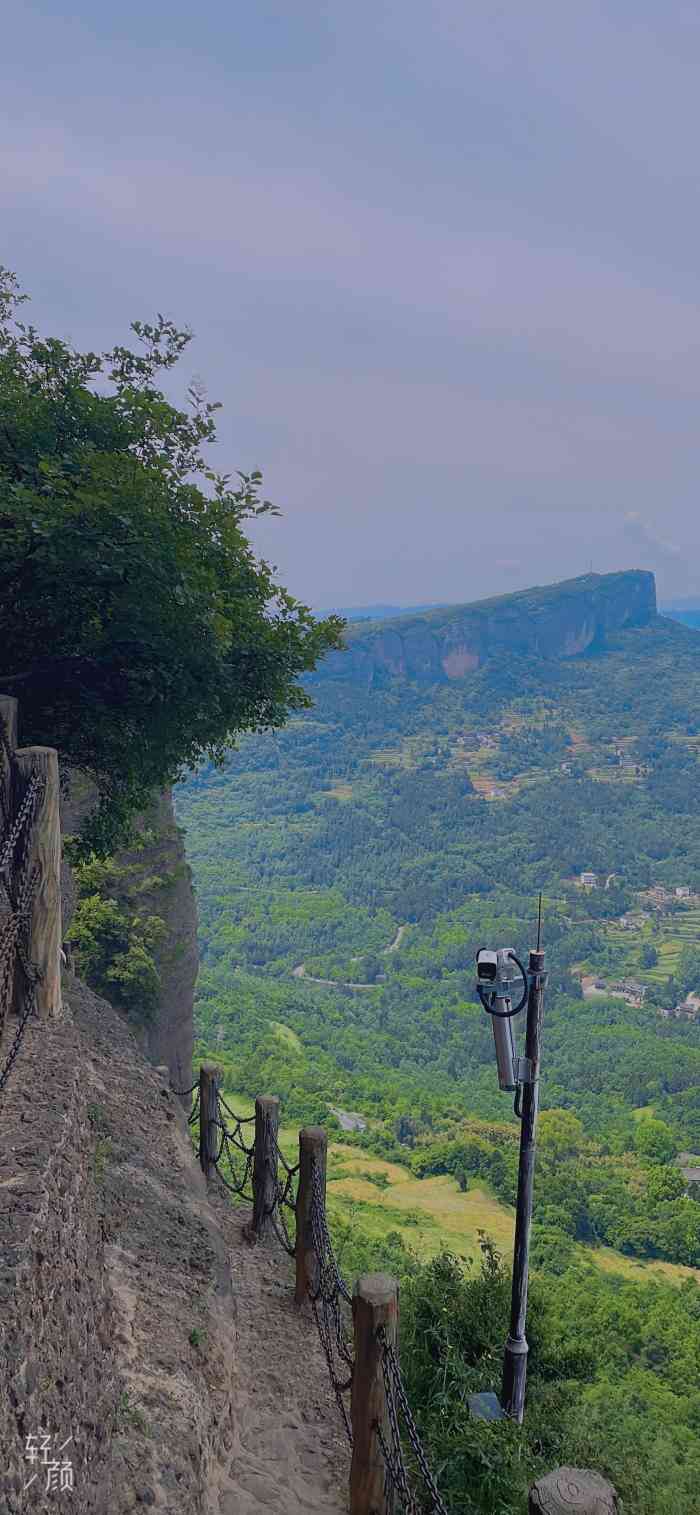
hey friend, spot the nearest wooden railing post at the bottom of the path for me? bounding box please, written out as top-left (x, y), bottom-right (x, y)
top-left (350, 1273), bottom-right (398, 1515)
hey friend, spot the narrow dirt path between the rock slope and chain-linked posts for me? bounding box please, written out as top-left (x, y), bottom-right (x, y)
top-left (212, 1195), bottom-right (350, 1515)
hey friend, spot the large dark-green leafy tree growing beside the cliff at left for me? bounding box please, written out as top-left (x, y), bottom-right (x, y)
top-left (0, 270), bottom-right (342, 850)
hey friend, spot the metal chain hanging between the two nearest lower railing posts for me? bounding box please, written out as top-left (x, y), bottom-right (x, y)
top-left (309, 1162), bottom-right (355, 1444)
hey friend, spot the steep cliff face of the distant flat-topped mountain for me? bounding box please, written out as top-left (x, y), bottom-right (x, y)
top-left (320, 570), bottom-right (656, 685)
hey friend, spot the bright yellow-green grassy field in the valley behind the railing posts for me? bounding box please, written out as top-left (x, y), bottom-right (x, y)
top-left (216, 1089), bottom-right (700, 1283)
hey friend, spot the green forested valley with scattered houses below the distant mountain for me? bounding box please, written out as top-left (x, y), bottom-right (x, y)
top-left (176, 606), bottom-right (700, 1515)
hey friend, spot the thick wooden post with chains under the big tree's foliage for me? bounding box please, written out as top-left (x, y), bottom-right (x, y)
top-left (12, 747), bottom-right (62, 1018)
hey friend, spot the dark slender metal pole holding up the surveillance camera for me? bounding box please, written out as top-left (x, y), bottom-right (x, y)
top-left (502, 933), bottom-right (545, 1426)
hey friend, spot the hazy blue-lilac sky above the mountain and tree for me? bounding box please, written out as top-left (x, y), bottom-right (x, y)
top-left (0, 0), bottom-right (700, 608)
